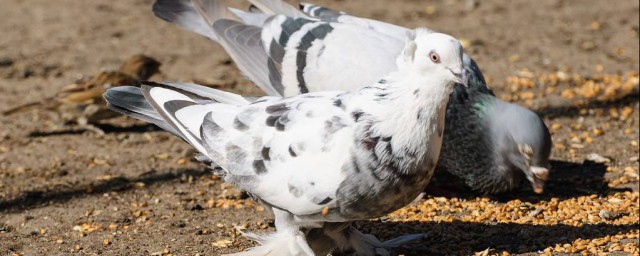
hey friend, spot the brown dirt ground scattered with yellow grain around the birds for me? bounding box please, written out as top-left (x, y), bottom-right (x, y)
top-left (0, 0), bottom-right (640, 255)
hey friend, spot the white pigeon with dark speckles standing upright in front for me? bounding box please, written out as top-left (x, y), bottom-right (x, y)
top-left (105, 29), bottom-right (465, 256)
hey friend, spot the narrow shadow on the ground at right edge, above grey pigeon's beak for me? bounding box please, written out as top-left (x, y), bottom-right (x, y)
top-left (535, 89), bottom-right (640, 118)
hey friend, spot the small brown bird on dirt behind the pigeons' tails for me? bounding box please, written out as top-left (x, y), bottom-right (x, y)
top-left (2, 54), bottom-right (161, 134)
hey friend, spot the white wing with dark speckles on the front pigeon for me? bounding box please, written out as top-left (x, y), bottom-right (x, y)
top-left (142, 85), bottom-right (354, 215)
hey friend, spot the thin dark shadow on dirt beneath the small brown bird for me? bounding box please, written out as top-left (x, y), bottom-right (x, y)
top-left (28, 124), bottom-right (162, 137)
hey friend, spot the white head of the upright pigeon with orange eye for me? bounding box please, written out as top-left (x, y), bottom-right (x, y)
top-left (398, 29), bottom-right (467, 86)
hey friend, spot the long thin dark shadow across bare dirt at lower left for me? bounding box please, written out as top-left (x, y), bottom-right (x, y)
top-left (0, 169), bottom-right (211, 213)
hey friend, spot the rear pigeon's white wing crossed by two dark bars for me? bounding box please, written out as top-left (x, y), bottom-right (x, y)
top-left (214, 15), bottom-right (403, 96)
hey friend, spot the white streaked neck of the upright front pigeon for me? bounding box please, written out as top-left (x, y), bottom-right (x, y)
top-left (357, 72), bottom-right (453, 174)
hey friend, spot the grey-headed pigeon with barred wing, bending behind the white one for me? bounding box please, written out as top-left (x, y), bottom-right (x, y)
top-left (153, 0), bottom-right (551, 193)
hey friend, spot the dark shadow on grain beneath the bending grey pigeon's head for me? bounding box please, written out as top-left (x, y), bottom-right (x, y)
top-left (425, 161), bottom-right (631, 203)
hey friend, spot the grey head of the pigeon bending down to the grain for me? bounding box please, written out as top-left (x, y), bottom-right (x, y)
top-left (494, 102), bottom-right (551, 193)
